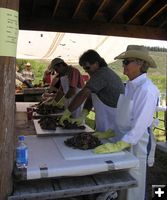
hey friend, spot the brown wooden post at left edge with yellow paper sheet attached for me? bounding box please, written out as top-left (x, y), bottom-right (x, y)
top-left (0, 0), bottom-right (19, 200)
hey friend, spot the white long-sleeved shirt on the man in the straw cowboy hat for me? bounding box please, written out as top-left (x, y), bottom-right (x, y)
top-left (122, 74), bottom-right (159, 145)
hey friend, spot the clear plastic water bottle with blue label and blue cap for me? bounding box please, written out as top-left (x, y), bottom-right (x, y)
top-left (16, 135), bottom-right (28, 168)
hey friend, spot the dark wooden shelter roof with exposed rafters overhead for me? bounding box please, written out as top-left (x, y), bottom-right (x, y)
top-left (19, 0), bottom-right (167, 40)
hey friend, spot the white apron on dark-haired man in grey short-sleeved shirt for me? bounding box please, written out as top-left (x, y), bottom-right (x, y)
top-left (91, 93), bottom-right (116, 131)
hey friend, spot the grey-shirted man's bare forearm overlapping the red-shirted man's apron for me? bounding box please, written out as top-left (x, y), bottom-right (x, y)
top-left (68, 87), bottom-right (91, 112)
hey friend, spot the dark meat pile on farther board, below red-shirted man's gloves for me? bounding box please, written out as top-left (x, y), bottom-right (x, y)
top-left (36, 104), bottom-right (64, 115)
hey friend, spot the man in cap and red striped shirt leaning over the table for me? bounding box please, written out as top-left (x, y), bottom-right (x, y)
top-left (50, 58), bottom-right (84, 118)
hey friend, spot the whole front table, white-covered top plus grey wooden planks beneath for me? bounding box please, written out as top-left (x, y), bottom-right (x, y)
top-left (8, 135), bottom-right (139, 200)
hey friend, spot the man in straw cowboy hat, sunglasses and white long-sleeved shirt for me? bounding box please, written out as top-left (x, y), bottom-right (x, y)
top-left (94, 45), bottom-right (159, 200)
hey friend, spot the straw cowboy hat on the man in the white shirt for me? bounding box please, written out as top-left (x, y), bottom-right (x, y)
top-left (114, 45), bottom-right (157, 68)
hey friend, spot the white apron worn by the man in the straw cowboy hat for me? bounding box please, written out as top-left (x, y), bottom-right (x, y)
top-left (116, 95), bottom-right (155, 200)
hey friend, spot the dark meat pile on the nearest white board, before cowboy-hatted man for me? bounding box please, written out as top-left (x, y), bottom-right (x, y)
top-left (64, 133), bottom-right (102, 150)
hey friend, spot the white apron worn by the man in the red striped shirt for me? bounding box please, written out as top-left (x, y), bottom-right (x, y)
top-left (60, 75), bottom-right (83, 118)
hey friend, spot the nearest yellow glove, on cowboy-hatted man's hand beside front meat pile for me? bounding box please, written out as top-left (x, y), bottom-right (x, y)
top-left (93, 141), bottom-right (131, 154)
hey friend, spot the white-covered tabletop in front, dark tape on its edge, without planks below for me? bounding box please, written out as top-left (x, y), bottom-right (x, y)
top-left (20, 136), bottom-right (138, 180)
